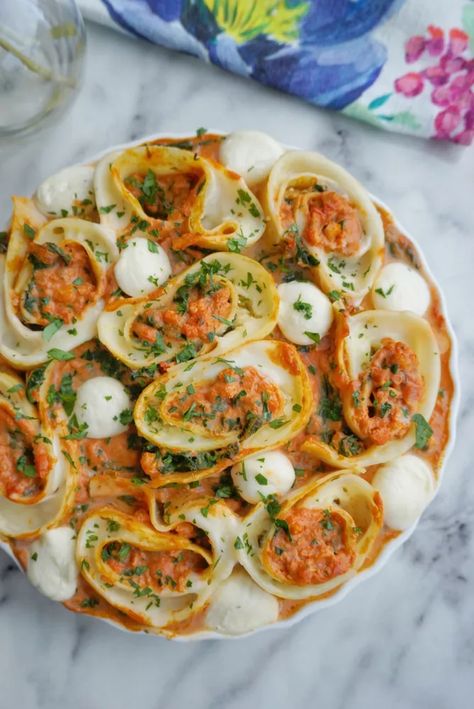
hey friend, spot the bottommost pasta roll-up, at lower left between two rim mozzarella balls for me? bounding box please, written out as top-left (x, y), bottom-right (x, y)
top-left (76, 501), bottom-right (238, 632)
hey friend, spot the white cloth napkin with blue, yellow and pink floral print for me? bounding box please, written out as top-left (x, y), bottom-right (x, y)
top-left (79, 0), bottom-right (474, 145)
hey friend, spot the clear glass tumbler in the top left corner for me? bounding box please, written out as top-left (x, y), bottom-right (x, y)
top-left (0, 0), bottom-right (86, 140)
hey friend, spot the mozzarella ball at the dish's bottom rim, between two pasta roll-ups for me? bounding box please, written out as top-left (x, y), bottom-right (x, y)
top-left (206, 570), bottom-right (278, 635)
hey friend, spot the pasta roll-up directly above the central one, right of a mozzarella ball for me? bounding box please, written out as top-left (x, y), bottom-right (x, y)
top-left (98, 253), bottom-right (278, 369)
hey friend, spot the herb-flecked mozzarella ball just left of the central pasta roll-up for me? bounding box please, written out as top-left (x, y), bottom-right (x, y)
top-left (74, 377), bottom-right (130, 438)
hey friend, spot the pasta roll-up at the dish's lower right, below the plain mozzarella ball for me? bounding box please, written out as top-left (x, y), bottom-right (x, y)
top-left (235, 470), bottom-right (383, 600)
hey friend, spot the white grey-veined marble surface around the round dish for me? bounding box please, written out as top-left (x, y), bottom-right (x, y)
top-left (0, 20), bottom-right (474, 709)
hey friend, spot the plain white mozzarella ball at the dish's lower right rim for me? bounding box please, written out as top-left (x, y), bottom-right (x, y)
top-left (372, 454), bottom-right (434, 529)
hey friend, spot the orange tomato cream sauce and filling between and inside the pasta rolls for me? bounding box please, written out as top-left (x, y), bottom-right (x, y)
top-left (0, 134), bottom-right (454, 636)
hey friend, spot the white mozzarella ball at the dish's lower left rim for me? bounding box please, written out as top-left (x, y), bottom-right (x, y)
top-left (27, 527), bottom-right (78, 601)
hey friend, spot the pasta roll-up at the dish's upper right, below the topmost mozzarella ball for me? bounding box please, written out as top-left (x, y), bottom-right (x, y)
top-left (265, 151), bottom-right (385, 300)
